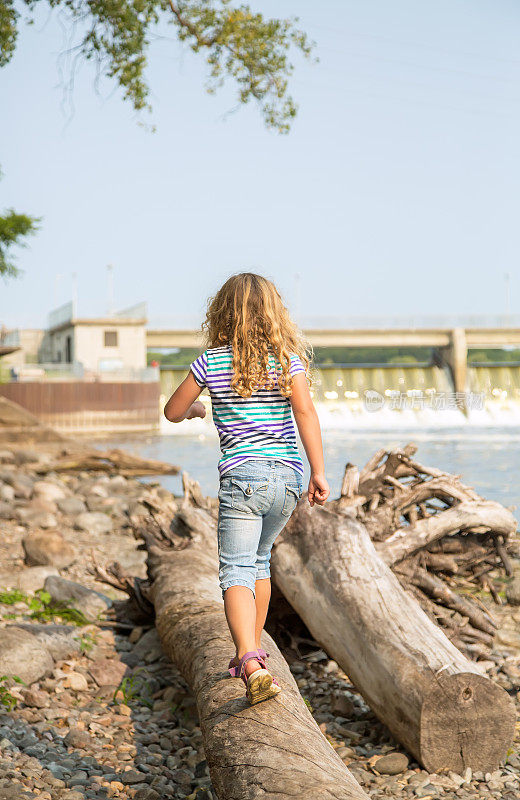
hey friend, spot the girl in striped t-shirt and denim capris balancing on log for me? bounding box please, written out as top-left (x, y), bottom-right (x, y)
top-left (164, 272), bottom-right (329, 703)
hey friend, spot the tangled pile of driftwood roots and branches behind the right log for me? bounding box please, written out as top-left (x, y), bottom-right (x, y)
top-left (331, 444), bottom-right (519, 657)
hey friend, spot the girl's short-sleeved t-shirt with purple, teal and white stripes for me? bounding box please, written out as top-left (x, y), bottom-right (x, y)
top-left (190, 345), bottom-right (305, 475)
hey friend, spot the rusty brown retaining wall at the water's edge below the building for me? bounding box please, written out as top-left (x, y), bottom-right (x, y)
top-left (0, 381), bottom-right (160, 432)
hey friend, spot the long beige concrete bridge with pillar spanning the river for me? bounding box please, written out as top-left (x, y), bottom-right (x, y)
top-left (146, 324), bottom-right (520, 392)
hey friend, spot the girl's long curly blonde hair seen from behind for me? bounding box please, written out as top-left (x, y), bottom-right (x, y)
top-left (202, 272), bottom-right (313, 397)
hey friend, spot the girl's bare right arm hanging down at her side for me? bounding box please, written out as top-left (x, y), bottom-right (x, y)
top-left (290, 372), bottom-right (330, 506)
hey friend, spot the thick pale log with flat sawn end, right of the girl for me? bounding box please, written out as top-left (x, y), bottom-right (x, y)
top-left (271, 501), bottom-right (516, 774)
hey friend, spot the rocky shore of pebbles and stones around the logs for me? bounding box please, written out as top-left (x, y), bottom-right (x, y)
top-left (0, 447), bottom-right (520, 800)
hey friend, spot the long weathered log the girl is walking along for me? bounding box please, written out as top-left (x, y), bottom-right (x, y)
top-left (136, 473), bottom-right (367, 800)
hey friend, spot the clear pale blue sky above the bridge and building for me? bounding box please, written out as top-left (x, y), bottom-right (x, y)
top-left (0, 0), bottom-right (520, 327)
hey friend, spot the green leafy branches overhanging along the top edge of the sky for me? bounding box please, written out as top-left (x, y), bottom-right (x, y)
top-left (0, 0), bottom-right (313, 133)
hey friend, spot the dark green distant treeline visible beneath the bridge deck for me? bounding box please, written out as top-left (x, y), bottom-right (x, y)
top-left (148, 347), bottom-right (520, 367)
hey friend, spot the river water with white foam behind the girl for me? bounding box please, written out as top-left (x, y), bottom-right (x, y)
top-left (95, 407), bottom-right (520, 511)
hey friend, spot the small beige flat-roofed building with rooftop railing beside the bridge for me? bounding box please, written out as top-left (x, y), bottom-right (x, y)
top-left (43, 303), bottom-right (146, 374)
